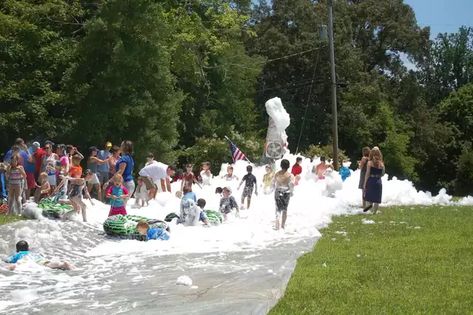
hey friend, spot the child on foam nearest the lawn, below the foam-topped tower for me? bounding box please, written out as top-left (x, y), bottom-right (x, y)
top-left (273, 159), bottom-right (294, 230)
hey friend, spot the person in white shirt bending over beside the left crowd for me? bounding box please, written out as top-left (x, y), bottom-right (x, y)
top-left (139, 162), bottom-right (176, 197)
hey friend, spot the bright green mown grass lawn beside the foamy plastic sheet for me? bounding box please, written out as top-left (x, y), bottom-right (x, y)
top-left (270, 206), bottom-right (473, 315)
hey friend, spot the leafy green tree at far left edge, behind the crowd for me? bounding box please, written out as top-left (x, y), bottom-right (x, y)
top-left (0, 0), bottom-right (85, 147)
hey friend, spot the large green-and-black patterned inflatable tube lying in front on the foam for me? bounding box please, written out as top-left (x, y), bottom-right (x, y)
top-left (103, 214), bottom-right (169, 240)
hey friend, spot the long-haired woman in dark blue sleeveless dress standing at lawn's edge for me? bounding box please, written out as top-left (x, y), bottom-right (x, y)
top-left (363, 147), bottom-right (385, 213)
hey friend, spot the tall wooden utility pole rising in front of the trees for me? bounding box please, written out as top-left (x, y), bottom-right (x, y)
top-left (328, 0), bottom-right (338, 170)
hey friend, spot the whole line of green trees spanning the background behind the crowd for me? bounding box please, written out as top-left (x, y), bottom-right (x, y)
top-left (0, 0), bottom-right (473, 194)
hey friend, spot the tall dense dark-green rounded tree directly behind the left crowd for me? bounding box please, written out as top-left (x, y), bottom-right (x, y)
top-left (65, 0), bottom-right (183, 159)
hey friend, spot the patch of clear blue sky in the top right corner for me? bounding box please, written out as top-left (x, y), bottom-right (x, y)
top-left (404, 0), bottom-right (473, 38)
